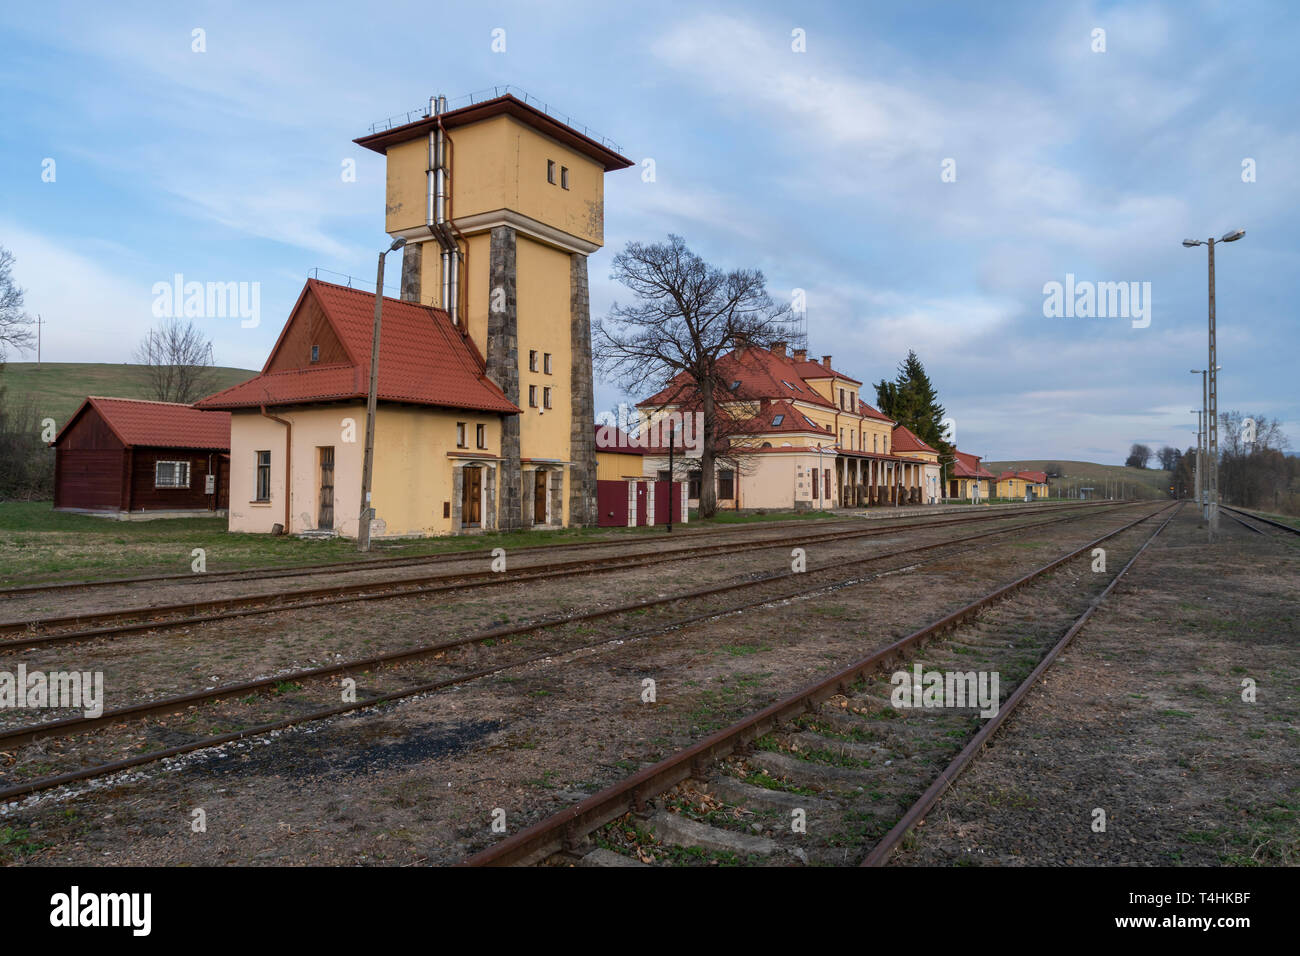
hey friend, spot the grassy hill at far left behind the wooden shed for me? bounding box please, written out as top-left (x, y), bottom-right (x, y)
top-left (0, 362), bottom-right (257, 427)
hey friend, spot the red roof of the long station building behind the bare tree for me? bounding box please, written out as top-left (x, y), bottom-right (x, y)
top-left (637, 345), bottom-right (893, 424)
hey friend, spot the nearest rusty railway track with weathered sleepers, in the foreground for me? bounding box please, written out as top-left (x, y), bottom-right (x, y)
top-left (463, 503), bottom-right (1180, 866)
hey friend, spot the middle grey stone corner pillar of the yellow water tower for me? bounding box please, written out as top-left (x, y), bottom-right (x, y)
top-left (486, 226), bottom-right (522, 531)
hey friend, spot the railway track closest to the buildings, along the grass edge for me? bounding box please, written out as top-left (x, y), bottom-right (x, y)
top-left (0, 496), bottom-right (1087, 601)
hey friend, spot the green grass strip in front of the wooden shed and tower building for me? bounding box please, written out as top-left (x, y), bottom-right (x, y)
top-left (0, 501), bottom-right (832, 588)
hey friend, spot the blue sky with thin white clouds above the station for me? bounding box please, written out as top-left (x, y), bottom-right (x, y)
top-left (0, 0), bottom-right (1300, 462)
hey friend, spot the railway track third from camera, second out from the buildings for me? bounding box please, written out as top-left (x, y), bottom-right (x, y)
top-left (0, 496), bottom-right (1131, 650)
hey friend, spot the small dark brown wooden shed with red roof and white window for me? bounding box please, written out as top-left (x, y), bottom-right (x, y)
top-left (53, 395), bottom-right (230, 514)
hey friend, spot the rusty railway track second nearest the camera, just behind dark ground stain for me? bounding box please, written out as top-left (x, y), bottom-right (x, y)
top-left (0, 502), bottom-right (1149, 803)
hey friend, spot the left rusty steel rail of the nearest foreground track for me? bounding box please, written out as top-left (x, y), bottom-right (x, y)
top-left (459, 505), bottom-right (1175, 866)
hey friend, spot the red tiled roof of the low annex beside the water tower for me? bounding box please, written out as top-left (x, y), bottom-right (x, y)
top-left (196, 278), bottom-right (519, 414)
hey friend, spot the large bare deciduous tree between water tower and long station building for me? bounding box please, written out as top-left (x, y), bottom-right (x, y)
top-left (593, 235), bottom-right (790, 518)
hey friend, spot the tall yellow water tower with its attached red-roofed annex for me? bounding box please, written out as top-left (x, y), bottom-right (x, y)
top-left (198, 95), bottom-right (632, 538)
